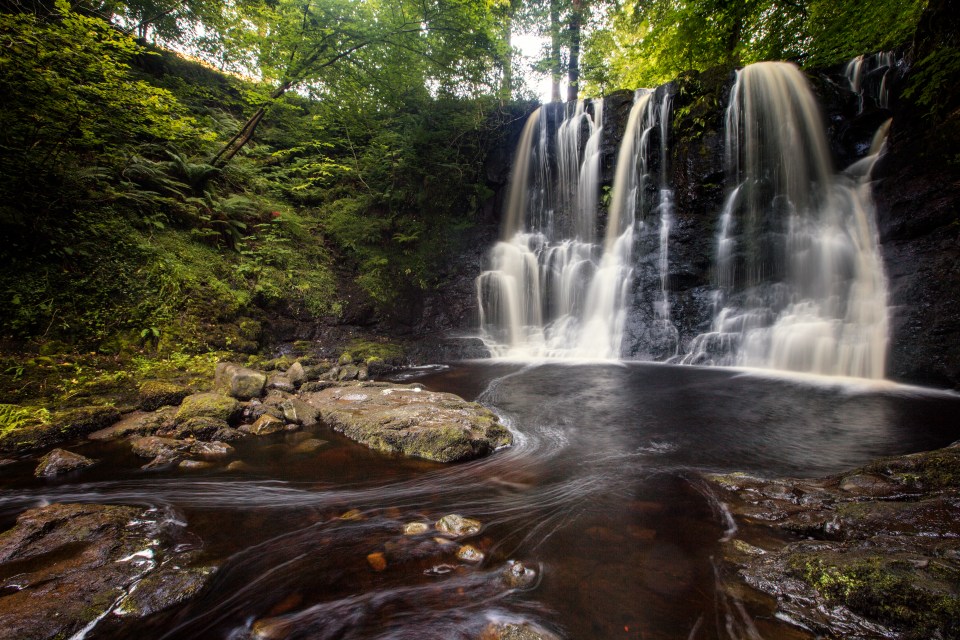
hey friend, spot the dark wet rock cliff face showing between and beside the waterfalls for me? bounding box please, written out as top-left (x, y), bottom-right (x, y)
top-left (412, 0), bottom-right (960, 387)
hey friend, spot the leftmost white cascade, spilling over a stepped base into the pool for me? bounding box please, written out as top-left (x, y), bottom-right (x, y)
top-left (477, 100), bottom-right (622, 358)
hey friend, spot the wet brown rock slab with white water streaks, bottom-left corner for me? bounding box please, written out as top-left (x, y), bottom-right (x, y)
top-left (0, 504), bottom-right (213, 640)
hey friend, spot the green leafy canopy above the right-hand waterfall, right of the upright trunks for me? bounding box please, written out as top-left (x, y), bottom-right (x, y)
top-left (584, 0), bottom-right (926, 94)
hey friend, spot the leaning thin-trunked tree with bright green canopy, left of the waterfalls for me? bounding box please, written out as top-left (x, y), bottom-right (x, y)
top-left (205, 0), bottom-right (495, 165)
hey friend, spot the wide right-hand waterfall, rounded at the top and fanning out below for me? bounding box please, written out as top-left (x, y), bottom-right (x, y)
top-left (682, 62), bottom-right (888, 378)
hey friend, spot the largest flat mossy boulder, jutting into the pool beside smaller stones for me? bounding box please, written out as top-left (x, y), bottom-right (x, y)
top-left (302, 383), bottom-right (512, 462)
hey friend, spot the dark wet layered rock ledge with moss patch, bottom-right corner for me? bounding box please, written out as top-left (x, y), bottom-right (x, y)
top-left (705, 442), bottom-right (960, 640)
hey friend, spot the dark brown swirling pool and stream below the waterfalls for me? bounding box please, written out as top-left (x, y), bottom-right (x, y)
top-left (0, 363), bottom-right (960, 640)
